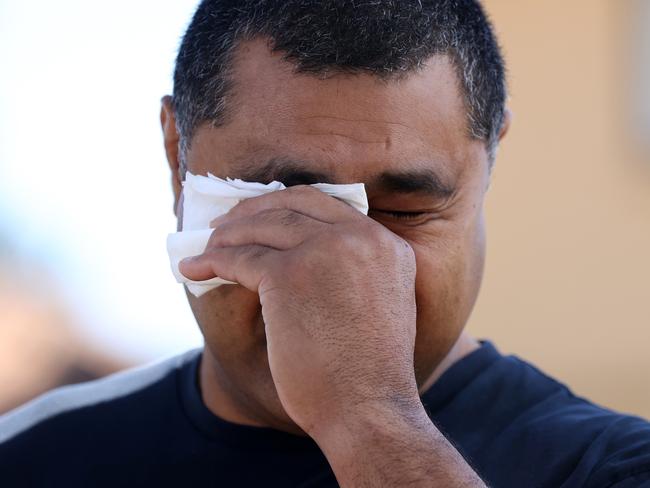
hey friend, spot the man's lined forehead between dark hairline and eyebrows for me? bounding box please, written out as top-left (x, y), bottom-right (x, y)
top-left (188, 39), bottom-right (484, 186)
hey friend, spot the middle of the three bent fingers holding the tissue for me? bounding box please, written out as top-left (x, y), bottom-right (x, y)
top-left (206, 208), bottom-right (331, 250)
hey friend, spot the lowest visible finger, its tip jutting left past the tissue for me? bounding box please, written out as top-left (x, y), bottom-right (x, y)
top-left (178, 245), bottom-right (280, 292)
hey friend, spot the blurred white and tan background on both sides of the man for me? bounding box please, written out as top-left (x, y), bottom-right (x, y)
top-left (0, 0), bottom-right (650, 417)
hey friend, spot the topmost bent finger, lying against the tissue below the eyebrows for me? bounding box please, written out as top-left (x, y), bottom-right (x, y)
top-left (210, 185), bottom-right (363, 226)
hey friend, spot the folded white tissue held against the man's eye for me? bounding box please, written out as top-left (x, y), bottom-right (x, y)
top-left (167, 171), bottom-right (368, 297)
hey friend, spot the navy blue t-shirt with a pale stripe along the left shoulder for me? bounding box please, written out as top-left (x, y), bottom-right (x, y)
top-left (0, 341), bottom-right (650, 488)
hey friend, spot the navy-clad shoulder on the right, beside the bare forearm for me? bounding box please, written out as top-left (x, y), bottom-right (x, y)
top-left (427, 344), bottom-right (650, 488)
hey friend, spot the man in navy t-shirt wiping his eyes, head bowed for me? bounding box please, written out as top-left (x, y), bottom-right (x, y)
top-left (0, 0), bottom-right (650, 488)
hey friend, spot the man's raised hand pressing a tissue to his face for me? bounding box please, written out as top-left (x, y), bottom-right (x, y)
top-left (180, 186), bottom-right (421, 440)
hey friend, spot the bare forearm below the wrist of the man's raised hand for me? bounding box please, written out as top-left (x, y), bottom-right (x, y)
top-left (315, 407), bottom-right (486, 488)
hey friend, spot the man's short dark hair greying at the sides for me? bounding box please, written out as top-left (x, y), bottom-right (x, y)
top-left (173, 0), bottom-right (506, 162)
